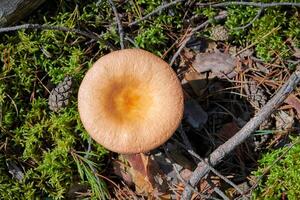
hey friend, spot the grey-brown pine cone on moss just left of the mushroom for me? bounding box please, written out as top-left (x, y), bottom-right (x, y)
top-left (48, 76), bottom-right (73, 112)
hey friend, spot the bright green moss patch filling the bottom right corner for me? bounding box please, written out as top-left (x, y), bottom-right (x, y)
top-left (253, 138), bottom-right (300, 199)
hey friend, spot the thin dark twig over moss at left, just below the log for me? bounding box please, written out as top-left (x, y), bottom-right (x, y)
top-left (0, 24), bottom-right (100, 40)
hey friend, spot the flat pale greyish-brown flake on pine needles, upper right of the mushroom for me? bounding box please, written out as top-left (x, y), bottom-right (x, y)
top-left (192, 52), bottom-right (236, 78)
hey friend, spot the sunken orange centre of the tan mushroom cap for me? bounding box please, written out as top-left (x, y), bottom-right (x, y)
top-left (104, 77), bottom-right (152, 123)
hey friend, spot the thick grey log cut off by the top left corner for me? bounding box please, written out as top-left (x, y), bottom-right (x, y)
top-left (0, 0), bottom-right (45, 27)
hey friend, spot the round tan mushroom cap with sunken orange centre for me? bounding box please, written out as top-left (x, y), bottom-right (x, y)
top-left (78, 49), bottom-right (183, 153)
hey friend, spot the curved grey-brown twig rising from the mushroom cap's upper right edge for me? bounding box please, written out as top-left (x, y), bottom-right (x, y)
top-left (170, 12), bottom-right (227, 66)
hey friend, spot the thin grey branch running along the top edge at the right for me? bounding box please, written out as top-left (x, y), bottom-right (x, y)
top-left (197, 1), bottom-right (300, 8)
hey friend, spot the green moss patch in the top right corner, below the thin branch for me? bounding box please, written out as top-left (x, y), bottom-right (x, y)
top-left (226, 3), bottom-right (300, 61)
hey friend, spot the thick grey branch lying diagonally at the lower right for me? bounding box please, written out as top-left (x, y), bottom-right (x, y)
top-left (181, 70), bottom-right (300, 199)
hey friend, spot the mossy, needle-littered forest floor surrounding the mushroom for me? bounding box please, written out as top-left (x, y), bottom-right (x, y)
top-left (0, 0), bottom-right (300, 199)
